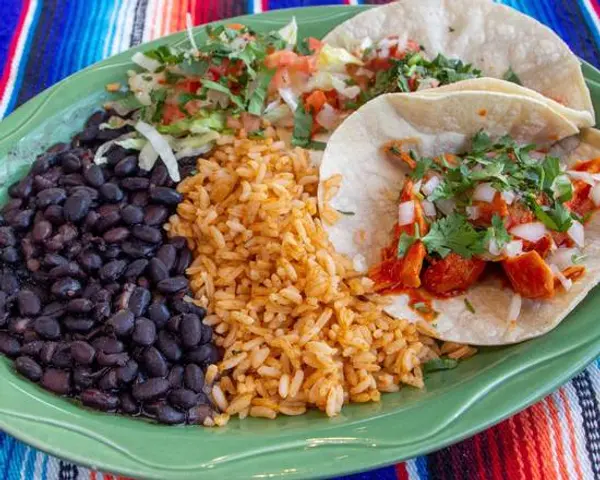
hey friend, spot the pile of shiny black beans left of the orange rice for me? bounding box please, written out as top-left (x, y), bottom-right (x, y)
top-left (0, 112), bottom-right (219, 424)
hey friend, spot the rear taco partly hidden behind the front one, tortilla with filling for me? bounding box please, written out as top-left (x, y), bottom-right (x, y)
top-left (324, 0), bottom-right (594, 127)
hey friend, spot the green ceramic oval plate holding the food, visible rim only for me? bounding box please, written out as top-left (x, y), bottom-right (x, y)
top-left (0, 7), bottom-right (600, 480)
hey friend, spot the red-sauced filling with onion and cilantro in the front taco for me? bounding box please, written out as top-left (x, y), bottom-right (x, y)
top-left (369, 131), bottom-right (600, 320)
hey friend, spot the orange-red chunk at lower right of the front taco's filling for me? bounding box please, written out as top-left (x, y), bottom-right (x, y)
top-left (502, 250), bottom-right (554, 298)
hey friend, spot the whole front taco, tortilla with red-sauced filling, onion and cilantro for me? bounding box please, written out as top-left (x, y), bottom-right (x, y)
top-left (319, 91), bottom-right (600, 345)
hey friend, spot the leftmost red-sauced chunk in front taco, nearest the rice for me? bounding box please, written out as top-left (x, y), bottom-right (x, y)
top-left (369, 241), bottom-right (427, 291)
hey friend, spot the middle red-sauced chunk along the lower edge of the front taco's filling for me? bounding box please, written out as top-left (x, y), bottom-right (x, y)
top-left (423, 253), bottom-right (486, 297)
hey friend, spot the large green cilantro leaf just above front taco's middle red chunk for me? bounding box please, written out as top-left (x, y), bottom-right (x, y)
top-left (422, 213), bottom-right (484, 258)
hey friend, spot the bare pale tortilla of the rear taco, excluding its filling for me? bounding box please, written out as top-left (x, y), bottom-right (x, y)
top-left (324, 0), bottom-right (594, 122)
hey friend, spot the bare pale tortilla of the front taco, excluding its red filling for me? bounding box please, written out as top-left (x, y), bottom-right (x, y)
top-left (319, 91), bottom-right (600, 345)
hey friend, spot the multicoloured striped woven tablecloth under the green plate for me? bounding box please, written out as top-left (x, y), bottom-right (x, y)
top-left (0, 0), bottom-right (600, 480)
